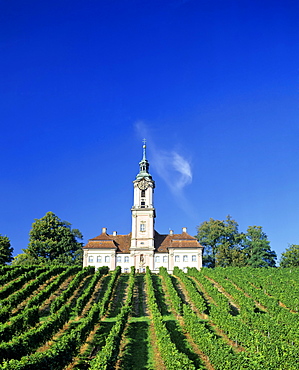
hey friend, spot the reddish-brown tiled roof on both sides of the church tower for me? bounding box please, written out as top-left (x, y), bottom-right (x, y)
top-left (83, 231), bottom-right (203, 253)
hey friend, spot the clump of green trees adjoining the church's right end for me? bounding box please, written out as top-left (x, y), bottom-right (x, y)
top-left (197, 216), bottom-right (276, 267)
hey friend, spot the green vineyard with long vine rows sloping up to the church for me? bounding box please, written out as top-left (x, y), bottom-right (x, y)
top-left (0, 266), bottom-right (299, 370)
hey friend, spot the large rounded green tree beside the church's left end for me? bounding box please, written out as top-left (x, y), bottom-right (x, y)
top-left (25, 212), bottom-right (83, 265)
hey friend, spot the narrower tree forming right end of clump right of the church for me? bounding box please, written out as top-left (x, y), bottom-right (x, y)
top-left (243, 226), bottom-right (277, 267)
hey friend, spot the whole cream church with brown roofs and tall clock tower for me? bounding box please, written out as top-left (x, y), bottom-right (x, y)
top-left (83, 144), bottom-right (203, 273)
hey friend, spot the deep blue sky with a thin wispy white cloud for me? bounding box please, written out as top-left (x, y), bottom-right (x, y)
top-left (0, 0), bottom-right (299, 262)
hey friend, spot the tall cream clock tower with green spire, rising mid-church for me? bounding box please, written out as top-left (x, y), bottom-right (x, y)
top-left (130, 139), bottom-right (156, 271)
